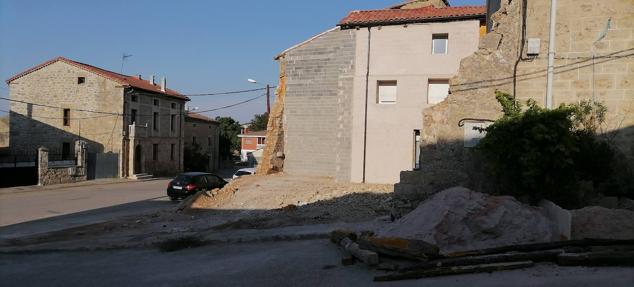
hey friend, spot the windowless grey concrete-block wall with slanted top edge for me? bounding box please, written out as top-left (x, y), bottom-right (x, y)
top-left (282, 29), bottom-right (355, 181)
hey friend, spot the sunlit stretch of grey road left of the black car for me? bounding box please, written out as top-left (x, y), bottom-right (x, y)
top-left (0, 180), bottom-right (174, 239)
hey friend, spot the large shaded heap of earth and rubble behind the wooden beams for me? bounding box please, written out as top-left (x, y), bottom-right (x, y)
top-left (377, 187), bottom-right (559, 253)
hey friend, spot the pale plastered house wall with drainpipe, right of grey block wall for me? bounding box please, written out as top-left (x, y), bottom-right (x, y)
top-left (351, 20), bottom-right (479, 183)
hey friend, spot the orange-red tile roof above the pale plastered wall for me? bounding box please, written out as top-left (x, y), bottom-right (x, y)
top-left (338, 6), bottom-right (486, 28)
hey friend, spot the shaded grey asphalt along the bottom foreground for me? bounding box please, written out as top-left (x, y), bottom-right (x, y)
top-left (0, 239), bottom-right (634, 287)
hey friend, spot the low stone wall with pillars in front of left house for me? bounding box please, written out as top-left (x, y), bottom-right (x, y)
top-left (38, 141), bottom-right (87, 186)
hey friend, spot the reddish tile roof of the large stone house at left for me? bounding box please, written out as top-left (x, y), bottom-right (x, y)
top-left (6, 57), bottom-right (189, 101)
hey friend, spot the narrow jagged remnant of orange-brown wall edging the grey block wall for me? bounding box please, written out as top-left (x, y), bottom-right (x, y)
top-left (256, 60), bottom-right (286, 174)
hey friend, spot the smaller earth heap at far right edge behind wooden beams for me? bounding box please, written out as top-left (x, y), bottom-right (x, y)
top-left (572, 206), bottom-right (634, 239)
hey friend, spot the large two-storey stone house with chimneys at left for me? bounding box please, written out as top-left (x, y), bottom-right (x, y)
top-left (6, 57), bottom-right (189, 177)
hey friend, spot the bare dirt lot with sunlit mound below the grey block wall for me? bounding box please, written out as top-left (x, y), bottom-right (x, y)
top-left (0, 174), bottom-right (393, 251)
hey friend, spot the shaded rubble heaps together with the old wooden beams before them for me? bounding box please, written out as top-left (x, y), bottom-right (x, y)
top-left (331, 187), bottom-right (634, 281)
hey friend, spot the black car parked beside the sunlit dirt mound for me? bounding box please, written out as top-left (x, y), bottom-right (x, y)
top-left (167, 172), bottom-right (227, 200)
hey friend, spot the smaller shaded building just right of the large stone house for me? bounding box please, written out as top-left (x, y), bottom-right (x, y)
top-left (185, 112), bottom-right (220, 172)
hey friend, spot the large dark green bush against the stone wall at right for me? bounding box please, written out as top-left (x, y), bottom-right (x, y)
top-left (477, 93), bottom-right (619, 207)
